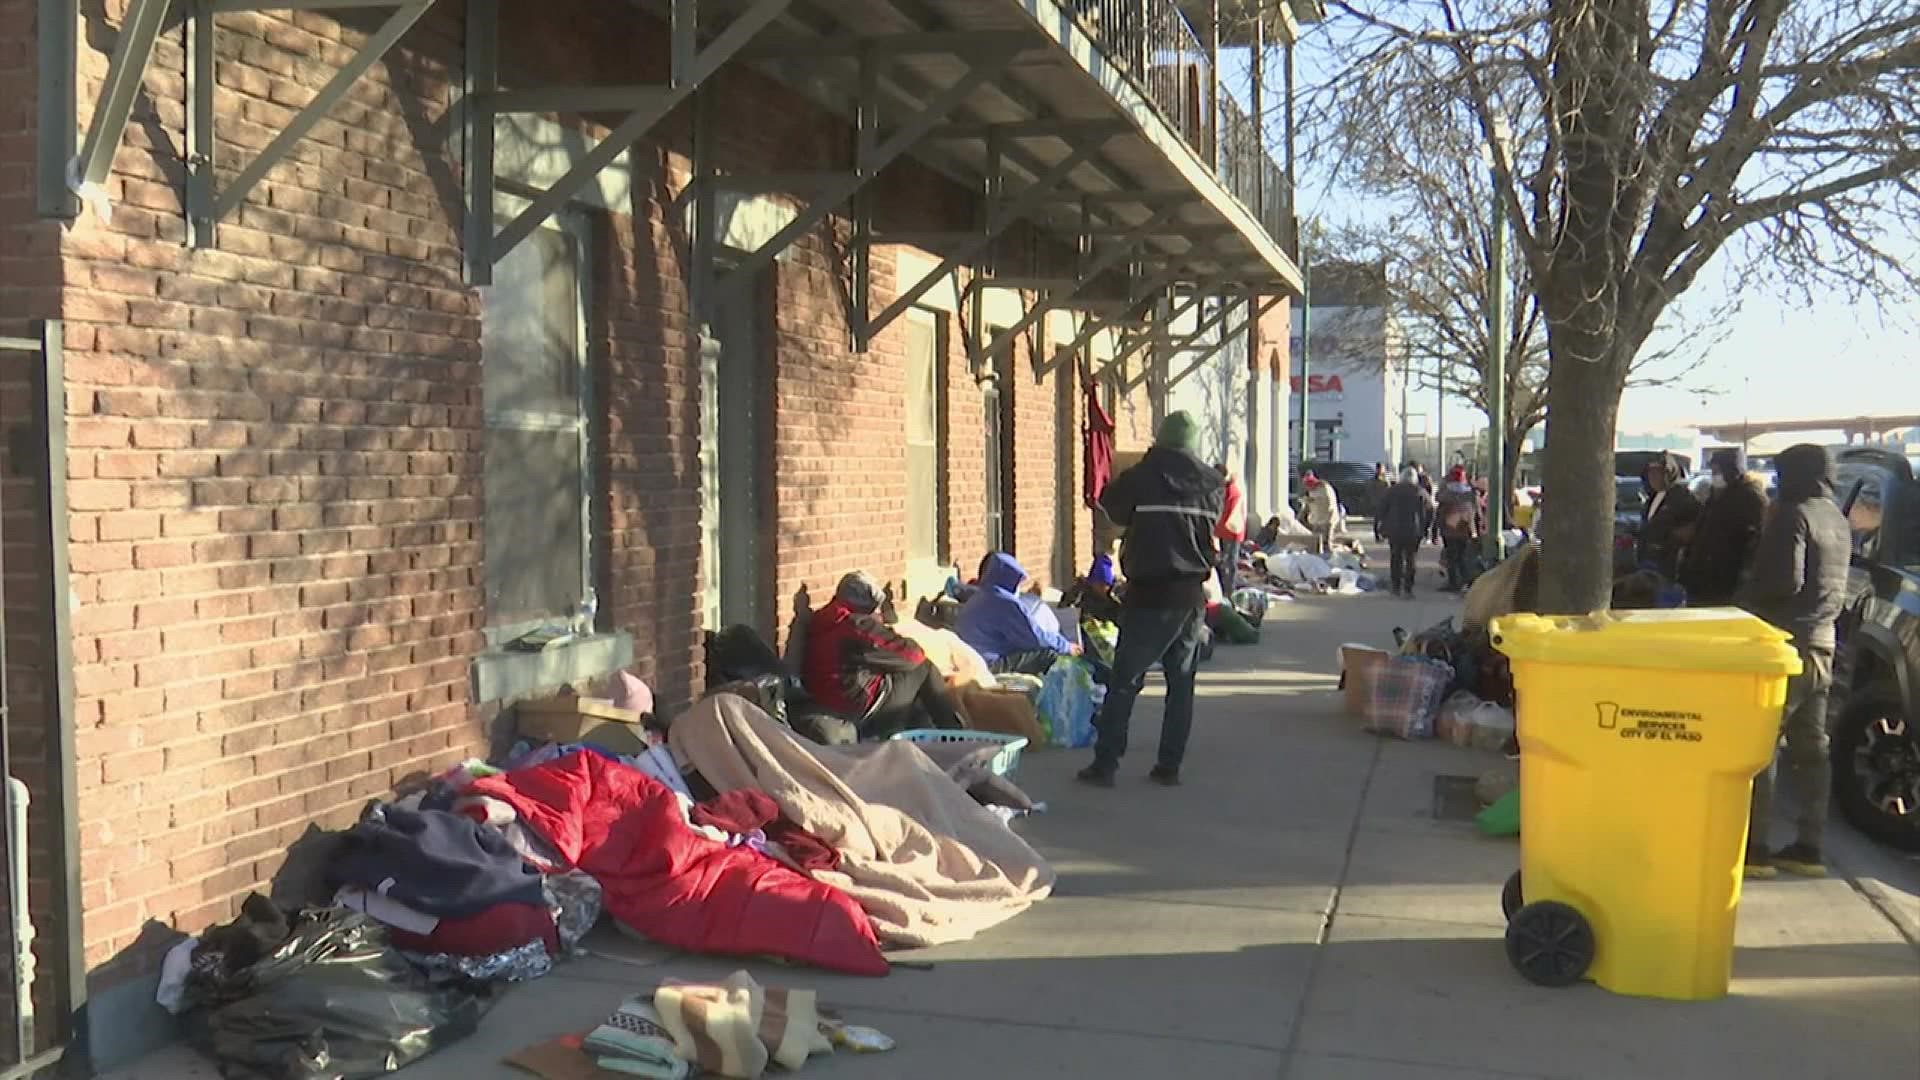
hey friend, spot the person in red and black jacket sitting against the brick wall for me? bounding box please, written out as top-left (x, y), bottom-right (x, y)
top-left (801, 571), bottom-right (966, 740)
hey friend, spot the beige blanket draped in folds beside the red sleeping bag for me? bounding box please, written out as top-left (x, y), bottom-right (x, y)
top-left (668, 694), bottom-right (1054, 945)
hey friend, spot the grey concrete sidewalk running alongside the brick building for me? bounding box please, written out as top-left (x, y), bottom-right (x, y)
top-left (112, 575), bottom-right (1920, 1080)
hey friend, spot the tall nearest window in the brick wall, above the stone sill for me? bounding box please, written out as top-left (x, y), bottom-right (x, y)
top-left (480, 209), bottom-right (591, 638)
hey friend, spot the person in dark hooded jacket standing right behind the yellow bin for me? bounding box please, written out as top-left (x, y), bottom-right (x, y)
top-left (1743, 442), bottom-right (1853, 878)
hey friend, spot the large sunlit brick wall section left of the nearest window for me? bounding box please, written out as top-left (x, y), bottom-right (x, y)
top-left (63, 4), bottom-right (482, 980)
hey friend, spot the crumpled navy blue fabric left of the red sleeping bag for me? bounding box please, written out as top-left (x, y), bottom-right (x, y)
top-left (332, 807), bottom-right (545, 919)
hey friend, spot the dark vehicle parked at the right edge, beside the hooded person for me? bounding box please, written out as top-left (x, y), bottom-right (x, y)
top-left (1828, 448), bottom-right (1920, 851)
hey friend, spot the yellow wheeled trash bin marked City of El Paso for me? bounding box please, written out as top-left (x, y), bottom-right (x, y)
top-left (1490, 607), bottom-right (1801, 999)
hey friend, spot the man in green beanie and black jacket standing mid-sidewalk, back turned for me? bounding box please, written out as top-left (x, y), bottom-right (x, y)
top-left (1079, 413), bottom-right (1225, 788)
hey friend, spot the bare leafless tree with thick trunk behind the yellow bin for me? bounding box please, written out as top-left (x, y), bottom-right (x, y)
top-left (1274, 0), bottom-right (1920, 611)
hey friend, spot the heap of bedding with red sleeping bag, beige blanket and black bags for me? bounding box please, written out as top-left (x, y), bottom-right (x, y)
top-left (157, 668), bottom-right (1052, 1080)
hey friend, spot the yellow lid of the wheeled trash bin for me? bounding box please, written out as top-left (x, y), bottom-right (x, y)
top-left (1488, 607), bottom-right (1801, 675)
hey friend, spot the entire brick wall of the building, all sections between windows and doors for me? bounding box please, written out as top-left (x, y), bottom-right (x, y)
top-left (52, 0), bottom-right (1144, 1006)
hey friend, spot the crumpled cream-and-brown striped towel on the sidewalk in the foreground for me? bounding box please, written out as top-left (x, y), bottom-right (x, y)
top-left (653, 970), bottom-right (833, 1080)
